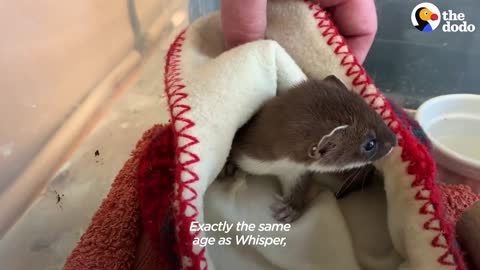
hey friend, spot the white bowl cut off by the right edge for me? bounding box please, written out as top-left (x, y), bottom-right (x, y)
top-left (416, 94), bottom-right (480, 183)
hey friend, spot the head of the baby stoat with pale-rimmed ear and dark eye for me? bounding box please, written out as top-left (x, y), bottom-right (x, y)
top-left (308, 77), bottom-right (397, 171)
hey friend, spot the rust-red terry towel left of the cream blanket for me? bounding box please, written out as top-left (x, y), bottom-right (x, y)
top-left (64, 126), bottom-right (173, 270)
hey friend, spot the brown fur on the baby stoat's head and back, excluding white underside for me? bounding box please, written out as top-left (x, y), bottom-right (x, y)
top-left (232, 76), bottom-right (396, 170)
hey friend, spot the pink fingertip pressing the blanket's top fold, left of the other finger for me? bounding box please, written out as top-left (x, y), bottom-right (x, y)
top-left (220, 0), bottom-right (267, 48)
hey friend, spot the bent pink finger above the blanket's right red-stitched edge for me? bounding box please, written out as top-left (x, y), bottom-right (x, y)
top-left (318, 0), bottom-right (377, 63)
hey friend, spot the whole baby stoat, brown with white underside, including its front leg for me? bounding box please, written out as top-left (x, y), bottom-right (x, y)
top-left (225, 75), bottom-right (397, 222)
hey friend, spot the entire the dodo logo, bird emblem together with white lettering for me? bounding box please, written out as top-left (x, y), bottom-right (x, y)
top-left (411, 2), bottom-right (475, 32)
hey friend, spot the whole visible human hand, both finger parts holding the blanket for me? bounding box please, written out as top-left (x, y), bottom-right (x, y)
top-left (220, 0), bottom-right (377, 63)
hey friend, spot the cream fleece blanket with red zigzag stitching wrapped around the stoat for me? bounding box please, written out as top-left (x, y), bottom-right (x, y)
top-left (165, 0), bottom-right (465, 270)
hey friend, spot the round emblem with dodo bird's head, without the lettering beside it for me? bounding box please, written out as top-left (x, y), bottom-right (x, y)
top-left (412, 3), bottom-right (441, 32)
